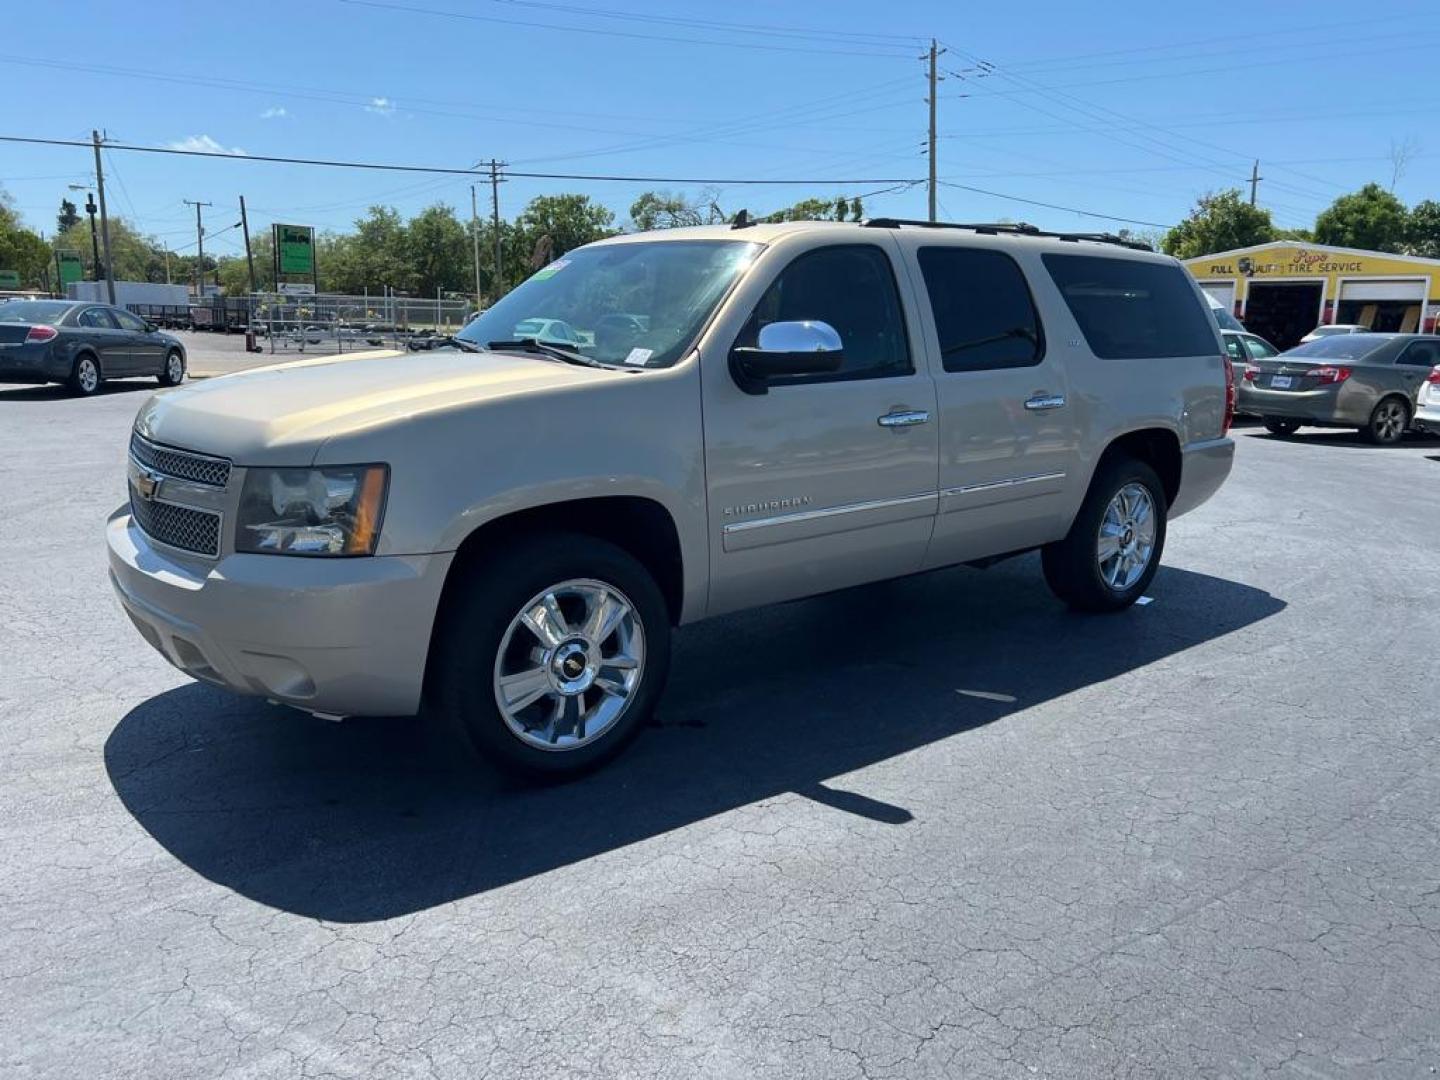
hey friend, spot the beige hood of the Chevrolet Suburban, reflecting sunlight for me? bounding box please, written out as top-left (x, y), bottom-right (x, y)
top-left (135, 350), bottom-right (626, 465)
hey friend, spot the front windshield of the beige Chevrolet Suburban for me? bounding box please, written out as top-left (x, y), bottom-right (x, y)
top-left (455, 240), bottom-right (760, 367)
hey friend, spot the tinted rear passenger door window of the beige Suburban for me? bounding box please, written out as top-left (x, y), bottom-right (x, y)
top-left (919, 248), bottom-right (1044, 372)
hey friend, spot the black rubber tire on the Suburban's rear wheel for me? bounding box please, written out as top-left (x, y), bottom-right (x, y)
top-left (1041, 458), bottom-right (1168, 612)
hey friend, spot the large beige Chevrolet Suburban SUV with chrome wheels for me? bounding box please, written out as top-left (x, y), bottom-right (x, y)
top-left (107, 220), bottom-right (1234, 776)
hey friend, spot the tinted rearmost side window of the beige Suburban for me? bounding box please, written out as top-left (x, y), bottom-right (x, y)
top-left (1043, 253), bottom-right (1215, 360)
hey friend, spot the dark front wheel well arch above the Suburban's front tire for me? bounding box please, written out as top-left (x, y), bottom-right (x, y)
top-left (441, 495), bottom-right (684, 625)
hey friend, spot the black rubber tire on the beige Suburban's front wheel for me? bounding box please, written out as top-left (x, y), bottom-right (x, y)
top-left (428, 533), bottom-right (670, 780)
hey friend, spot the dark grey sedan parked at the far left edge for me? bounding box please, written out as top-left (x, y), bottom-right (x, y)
top-left (0, 300), bottom-right (186, 396)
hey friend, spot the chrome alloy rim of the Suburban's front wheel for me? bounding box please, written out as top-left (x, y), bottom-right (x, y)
top-left (494, 577), bottom-right (645, 750)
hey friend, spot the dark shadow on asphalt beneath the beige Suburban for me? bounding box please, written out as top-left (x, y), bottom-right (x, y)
top-left (105, 556), bottom-right (1284, 922)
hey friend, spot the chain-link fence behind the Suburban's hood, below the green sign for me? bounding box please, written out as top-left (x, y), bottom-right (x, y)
top-left (249, 292), bottom-right (474, 353)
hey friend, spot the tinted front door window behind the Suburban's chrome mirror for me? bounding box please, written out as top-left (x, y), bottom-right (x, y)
top-left (736, 243), bottom-right (913, 386)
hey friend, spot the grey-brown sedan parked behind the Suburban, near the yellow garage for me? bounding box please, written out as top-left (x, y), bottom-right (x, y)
top-left (1237, 334), bottom-right (1440, 445)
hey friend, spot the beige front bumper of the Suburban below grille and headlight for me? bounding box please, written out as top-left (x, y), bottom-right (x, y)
top-left (105, 508), bottom-right (454, 716)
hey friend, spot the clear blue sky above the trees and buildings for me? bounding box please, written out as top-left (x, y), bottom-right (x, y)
top-left (0, 0), bottom-right (1440, 253)
